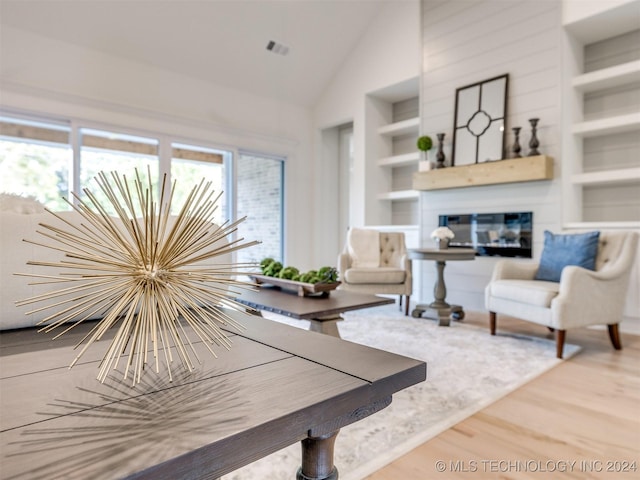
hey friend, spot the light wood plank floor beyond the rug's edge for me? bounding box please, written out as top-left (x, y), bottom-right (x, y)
top-left (367, 313), bottom-right (640, 480)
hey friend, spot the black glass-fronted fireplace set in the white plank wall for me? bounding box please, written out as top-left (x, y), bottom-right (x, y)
top-left (438, 212), bottom-right (533, 258)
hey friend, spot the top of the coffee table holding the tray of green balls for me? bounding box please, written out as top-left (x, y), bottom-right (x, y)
top-left (236, 286), bottom-right (394, 320)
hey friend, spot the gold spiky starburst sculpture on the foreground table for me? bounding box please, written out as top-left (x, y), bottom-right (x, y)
top-left (16, 171), bottom-right (258, 384)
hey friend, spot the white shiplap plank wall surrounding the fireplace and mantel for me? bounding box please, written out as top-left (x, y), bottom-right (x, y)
top-left (420, 0), bottom-right (563, 311)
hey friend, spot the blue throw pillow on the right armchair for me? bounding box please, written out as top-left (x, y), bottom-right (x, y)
top-left (535, 230), bottom-right (600, 282)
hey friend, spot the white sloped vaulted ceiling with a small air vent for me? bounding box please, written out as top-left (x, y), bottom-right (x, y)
top-left (0, 0), bottom-right (392, 107)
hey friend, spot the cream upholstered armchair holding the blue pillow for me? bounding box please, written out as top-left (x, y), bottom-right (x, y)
top-left (485, 232), bottom-right (638, 358)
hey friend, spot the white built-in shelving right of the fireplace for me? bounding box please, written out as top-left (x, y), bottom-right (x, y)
top-left (563, 0), bottom-right (640, 228)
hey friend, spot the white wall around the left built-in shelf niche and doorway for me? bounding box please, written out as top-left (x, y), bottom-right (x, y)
top-left (313, 0), bottom-right (421, 262)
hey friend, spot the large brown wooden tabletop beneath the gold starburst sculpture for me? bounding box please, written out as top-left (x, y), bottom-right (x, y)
top-left (0, 312), bottom-right (426, 480)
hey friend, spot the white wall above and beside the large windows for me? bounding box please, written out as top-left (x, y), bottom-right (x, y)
top-left (0, 26), bottom-right (316, 268)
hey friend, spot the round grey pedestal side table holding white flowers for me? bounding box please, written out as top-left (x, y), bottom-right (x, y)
top-left (409, 248), bottom-right (476, 327)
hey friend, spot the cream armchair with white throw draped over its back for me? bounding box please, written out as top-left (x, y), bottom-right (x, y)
top-left (338, 228), bottom-right (413, 315)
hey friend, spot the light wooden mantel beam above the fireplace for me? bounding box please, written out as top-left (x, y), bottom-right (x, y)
top-left (413, 155), bottom-right (553, 190)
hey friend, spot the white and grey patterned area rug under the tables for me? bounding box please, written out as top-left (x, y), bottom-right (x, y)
top-left (223, 305), bottom-right (579, 480)
